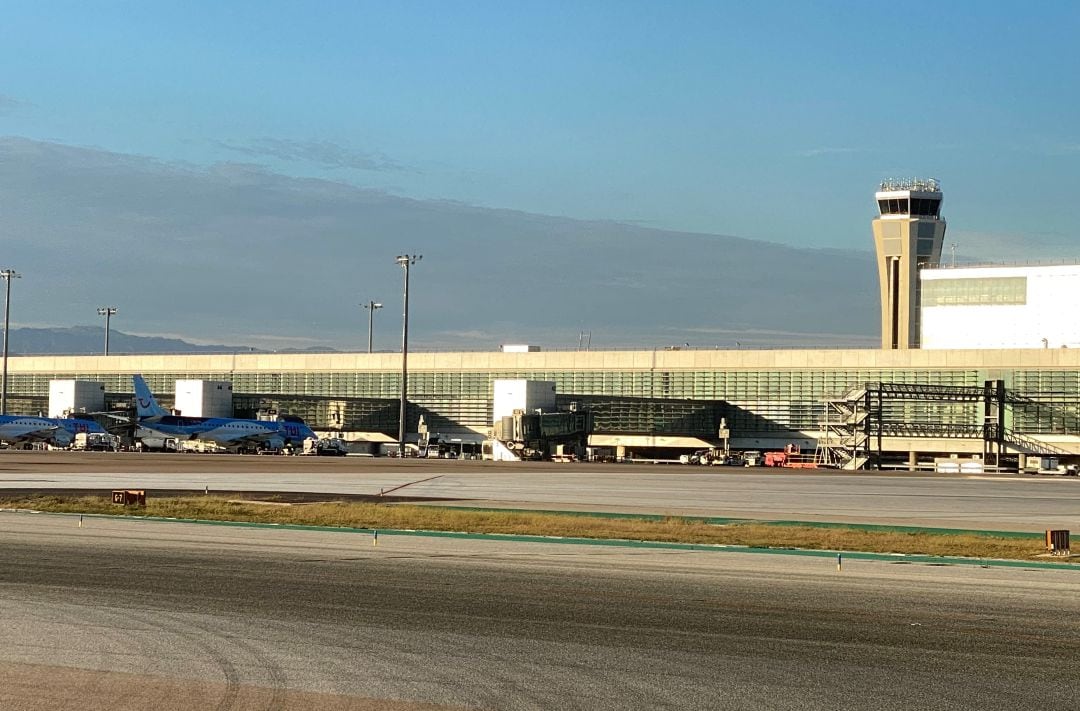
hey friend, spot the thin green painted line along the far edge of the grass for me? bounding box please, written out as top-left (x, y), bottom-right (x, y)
top-left (406, 504), bottom-right (1045, 540)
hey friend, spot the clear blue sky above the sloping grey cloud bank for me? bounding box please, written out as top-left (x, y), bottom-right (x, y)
top-left (0, 0), bottom-right (1080, 345)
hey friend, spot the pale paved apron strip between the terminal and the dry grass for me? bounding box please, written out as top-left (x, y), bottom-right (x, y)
top-left (0, 451), bottom-right (1080, 532)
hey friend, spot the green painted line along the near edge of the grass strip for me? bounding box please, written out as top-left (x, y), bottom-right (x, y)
top-left (5, 509), bottom-right (1080, 572)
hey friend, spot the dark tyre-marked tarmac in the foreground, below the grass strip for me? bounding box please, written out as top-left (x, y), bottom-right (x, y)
top-left (0, 513), bottom-right (1080, 711)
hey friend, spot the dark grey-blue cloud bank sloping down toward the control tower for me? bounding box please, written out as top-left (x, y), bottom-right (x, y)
top-left (0, 137), bottom-right (879, 353)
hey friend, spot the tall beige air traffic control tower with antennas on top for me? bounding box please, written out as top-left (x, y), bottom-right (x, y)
top-left (874, 178), bottom-right (945, 350)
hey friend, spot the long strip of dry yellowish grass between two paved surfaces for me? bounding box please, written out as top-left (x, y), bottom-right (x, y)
top-left (0, 496), bottom-right (1062, 560)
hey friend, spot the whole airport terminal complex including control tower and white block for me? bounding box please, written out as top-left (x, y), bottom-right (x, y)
top-left (8, 180), bottom-right (1080, 468)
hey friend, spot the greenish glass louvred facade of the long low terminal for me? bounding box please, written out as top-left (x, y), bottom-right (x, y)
top-left (9, 368), bottom-right (1080, 437)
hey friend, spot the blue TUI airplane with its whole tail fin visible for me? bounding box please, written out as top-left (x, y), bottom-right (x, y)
top-left (133, 375), bottom-right (319, 450)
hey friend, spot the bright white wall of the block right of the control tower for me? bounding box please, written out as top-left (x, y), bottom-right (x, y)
top-left (919, 265), bottom-right (1080, 349)
